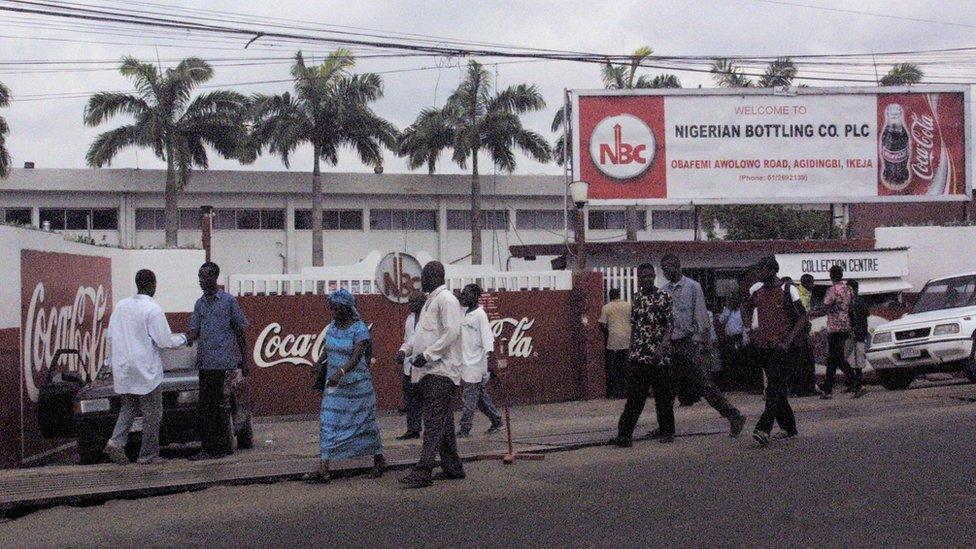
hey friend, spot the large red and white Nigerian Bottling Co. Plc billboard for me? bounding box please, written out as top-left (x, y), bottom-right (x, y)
top-left (571, 86), bottom-right (971, 205)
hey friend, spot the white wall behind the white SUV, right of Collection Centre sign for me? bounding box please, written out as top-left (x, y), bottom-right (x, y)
top-left (874, 227), bottom-right (976, 292)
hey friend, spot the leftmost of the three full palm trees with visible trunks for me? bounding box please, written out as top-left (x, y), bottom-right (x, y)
top-left (84, 56), bottom-right (247, 247)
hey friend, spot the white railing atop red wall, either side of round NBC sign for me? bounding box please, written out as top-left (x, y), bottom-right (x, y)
top-left (226, 271), bottom-right (573, 295)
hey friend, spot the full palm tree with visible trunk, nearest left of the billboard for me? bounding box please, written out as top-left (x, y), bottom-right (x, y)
top-left (400, 60), bottom-right (552, 265)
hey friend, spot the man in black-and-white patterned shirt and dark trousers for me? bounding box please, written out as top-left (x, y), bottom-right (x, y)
top-left (610, 263), bottom-right (674, 448)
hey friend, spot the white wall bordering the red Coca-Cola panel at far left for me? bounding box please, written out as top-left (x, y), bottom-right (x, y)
top-left (0, 225), bottom-right (204, 328)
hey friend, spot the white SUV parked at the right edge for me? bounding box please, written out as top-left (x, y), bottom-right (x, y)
top-left (867, 273), bottom-right (976, 390)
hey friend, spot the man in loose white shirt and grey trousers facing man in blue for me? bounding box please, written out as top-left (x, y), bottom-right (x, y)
top-left (105, 269), bottom-right (186, 465)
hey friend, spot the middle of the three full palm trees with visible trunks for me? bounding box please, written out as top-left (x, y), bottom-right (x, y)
top-left (252, 48), bottom-right (397, 267)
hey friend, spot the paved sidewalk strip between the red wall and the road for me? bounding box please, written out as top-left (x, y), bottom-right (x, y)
top-left (0, 376), bottom-right (976, 515)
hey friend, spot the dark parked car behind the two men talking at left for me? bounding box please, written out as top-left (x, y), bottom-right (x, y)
top-left (38, 349), bottom-right (254, 464)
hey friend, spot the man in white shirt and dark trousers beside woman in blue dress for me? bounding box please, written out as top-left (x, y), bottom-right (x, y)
top-left (396, 261), bottom-right (464, 488)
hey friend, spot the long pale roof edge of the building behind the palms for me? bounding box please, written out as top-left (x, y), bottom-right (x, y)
top-left (0, 169), bottom-right (566, 197)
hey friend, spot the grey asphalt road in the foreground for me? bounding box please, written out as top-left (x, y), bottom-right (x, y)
top-left (0, 385), bottom-right (976, 547)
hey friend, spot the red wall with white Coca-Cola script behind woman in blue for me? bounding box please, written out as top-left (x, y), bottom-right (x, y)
top-left (239, 291), bottom-right (578, 415)
